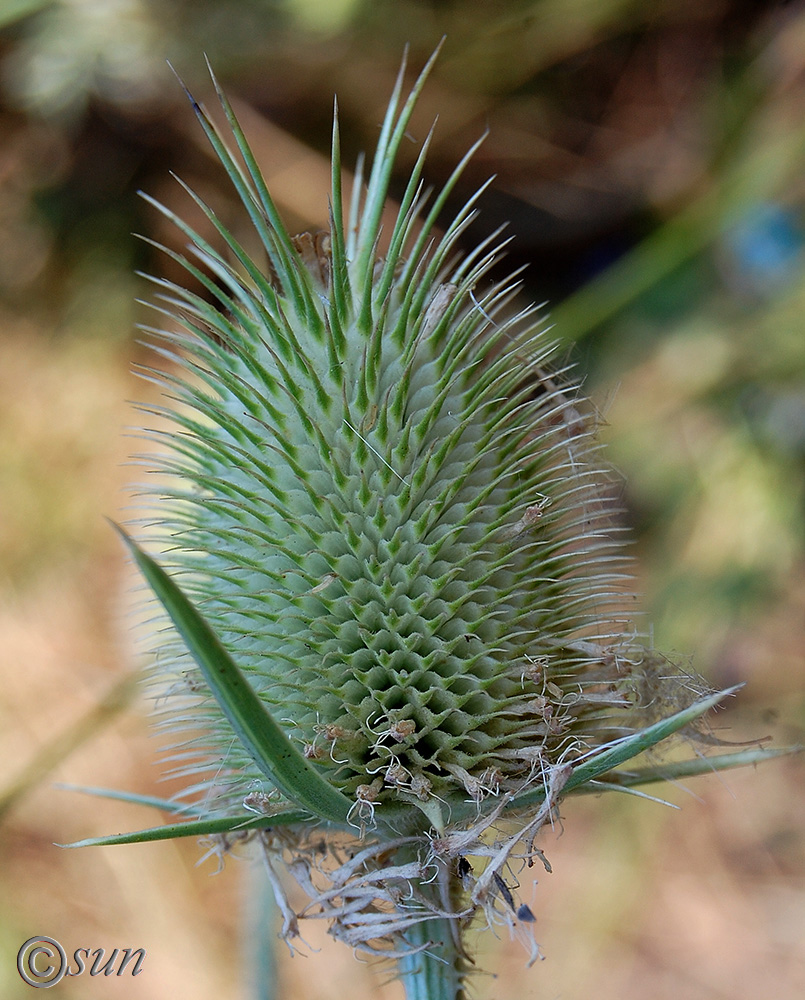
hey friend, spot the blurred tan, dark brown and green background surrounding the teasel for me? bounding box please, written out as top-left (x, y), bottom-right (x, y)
top-left (0, 0), bottom-right (805, 1000)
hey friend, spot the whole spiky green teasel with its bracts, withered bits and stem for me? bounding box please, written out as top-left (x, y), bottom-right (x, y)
top-left (64, 43), bottom-right (792, 1000)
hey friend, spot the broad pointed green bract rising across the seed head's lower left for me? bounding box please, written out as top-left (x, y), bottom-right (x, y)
top-left (114, 525), bottom-right (352, 824)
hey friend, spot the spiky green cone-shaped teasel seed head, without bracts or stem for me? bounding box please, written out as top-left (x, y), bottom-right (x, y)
top-left (138, 56), bottom-right (704, 825)
